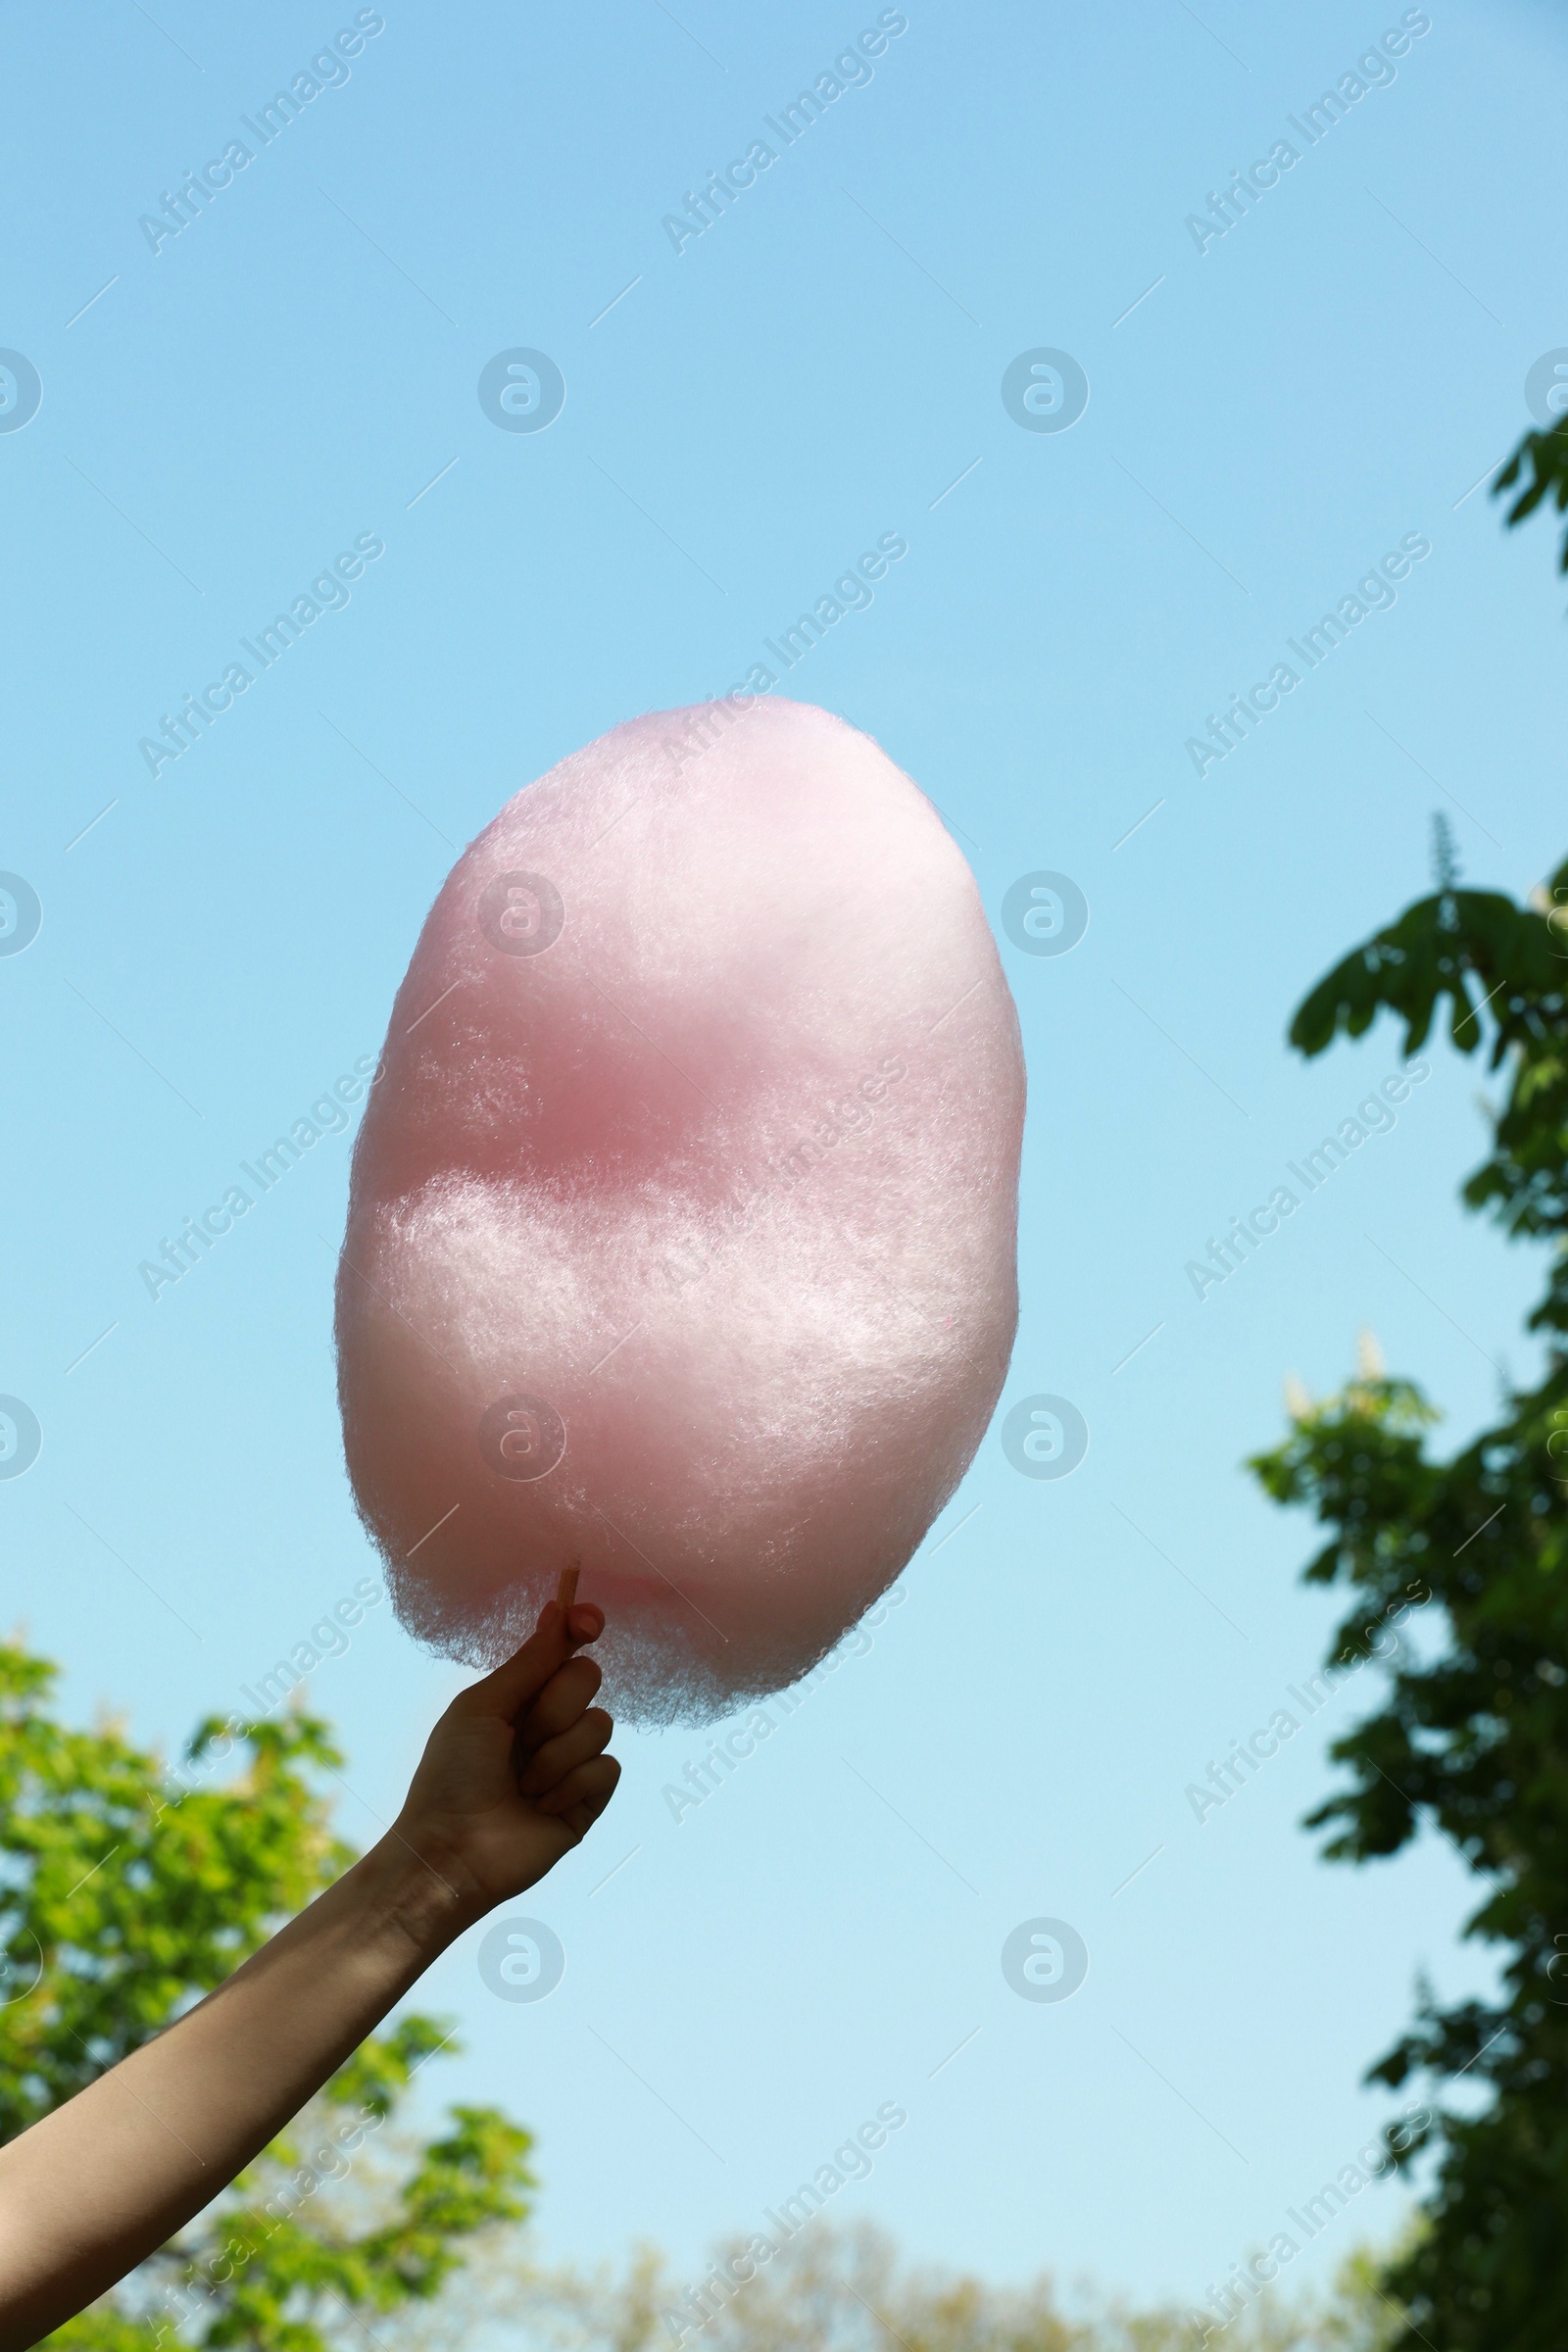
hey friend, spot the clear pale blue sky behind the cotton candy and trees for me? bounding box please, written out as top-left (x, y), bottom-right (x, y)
top-left (0, 0), bottom-right (1568, 2295)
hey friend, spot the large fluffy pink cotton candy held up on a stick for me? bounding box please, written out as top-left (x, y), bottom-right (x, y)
top-left (338, 699), bottom-right (1022, 1722)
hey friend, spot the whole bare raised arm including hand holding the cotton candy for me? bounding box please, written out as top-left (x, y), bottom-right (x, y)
top-left (0, 1601), bottom-right (620, 2352)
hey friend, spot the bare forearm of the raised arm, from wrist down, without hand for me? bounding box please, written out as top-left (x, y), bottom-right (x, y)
top-left (0, 1830), bottom-right (469, 2352)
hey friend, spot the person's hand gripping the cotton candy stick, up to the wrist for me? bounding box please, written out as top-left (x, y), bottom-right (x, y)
top-left (395, 1601), bottom-right (620, 1919)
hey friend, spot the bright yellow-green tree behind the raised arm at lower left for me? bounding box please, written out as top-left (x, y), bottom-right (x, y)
top-left (0, 1642), bottom-right (534, 2352)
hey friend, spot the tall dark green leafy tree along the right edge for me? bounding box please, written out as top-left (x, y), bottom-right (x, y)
top-left (1253, 425), bottom-right (1568, 2352)
